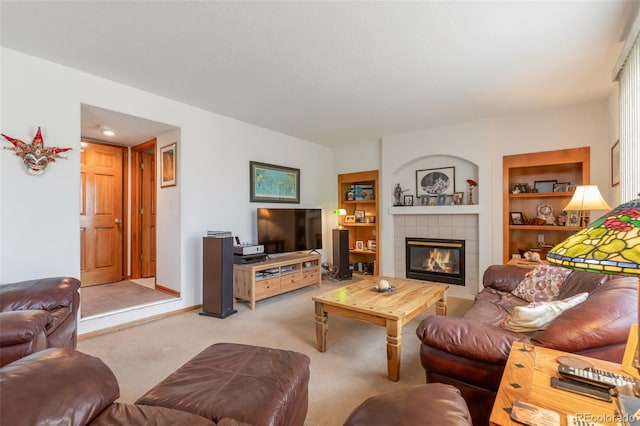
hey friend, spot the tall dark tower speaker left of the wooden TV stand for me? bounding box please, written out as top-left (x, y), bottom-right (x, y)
top-left (200, 237), bottom-right (237, 318)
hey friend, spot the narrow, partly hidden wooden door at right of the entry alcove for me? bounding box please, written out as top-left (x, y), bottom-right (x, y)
top-left (140, 152), bottom-right (156, 278)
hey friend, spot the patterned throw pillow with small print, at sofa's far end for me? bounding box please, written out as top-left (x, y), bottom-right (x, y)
top-left (511, 265), bottom-right (571, 302)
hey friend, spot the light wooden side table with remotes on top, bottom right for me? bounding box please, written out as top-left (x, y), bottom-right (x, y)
top-left (490, 342), bottom-right (626, 426)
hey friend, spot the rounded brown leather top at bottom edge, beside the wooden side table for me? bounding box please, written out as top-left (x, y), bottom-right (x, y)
top-left (344, 383), bottom-right (472, 426)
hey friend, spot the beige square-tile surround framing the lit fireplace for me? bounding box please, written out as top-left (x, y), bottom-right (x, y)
top-left (393, 215), bottom-right (479, 296)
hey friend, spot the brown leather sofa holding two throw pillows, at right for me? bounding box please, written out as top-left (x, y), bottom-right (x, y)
top-left (416, 265), bottom-right (638, 425)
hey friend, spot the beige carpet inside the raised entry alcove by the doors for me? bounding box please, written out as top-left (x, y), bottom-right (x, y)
top-left (80, 281), bottom-right (180, 318)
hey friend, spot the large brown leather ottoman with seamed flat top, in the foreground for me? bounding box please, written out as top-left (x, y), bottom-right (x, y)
top-left (136, 343), bottom-right (310, 426)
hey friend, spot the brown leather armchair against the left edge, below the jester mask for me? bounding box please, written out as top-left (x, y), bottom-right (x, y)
top-left (0, 277), bottom-right (80, 366)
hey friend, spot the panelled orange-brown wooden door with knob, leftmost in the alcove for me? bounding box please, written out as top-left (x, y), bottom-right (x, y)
top-left (80, 143), bottom-right (125, 286)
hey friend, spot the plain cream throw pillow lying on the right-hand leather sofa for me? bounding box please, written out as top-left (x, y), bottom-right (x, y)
top-left (500, 293), bottom-right (589, 333)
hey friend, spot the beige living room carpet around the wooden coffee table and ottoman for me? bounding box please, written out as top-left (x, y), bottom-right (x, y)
top-left (78, 281), bottom-right (472, 426)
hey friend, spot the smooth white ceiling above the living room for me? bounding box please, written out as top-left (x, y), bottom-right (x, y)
top-left (0, 0), bottom-right (639, 146)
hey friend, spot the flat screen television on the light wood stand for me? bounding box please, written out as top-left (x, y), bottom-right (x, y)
top-left (258, 208), bottom-right (322, 254)
